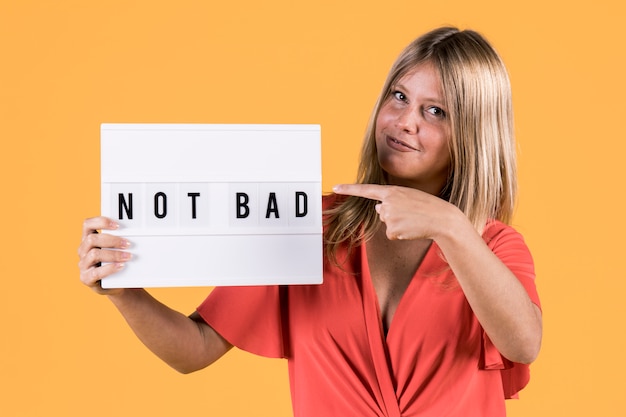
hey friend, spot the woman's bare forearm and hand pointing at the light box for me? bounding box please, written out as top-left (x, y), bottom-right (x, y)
top-left (335, 184), bottom-right (542, 363)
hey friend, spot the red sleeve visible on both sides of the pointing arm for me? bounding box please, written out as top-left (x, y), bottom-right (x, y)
top-left (481, 222), bottom-right (541, 399)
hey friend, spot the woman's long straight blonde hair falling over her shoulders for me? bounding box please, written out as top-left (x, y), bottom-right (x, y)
top-left (325, 27), bottom-right (517, 262)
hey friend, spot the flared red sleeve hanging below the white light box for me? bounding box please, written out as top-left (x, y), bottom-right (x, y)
top-left (197, 286), bottom-right (285, 358)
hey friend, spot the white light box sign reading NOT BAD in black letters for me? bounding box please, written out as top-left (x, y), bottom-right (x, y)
top-left (100, 124), bottom-right (323, 288)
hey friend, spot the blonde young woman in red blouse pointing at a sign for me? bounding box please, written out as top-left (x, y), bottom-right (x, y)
top-left (79, 28), bottom-right (542, 417)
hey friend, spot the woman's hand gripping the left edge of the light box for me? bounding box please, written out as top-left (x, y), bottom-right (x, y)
top-left (78, 217), bottom-right (132, 295)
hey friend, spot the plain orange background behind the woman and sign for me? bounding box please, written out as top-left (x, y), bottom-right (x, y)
top-left (0, 0), bottom-right (626, 417)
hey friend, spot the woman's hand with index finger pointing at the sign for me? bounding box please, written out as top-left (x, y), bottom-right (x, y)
top-left (333, 184), bottom-right (462, 240)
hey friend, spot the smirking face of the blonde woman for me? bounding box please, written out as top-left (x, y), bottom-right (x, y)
top-left (376, 63), bottom-right (450, 194)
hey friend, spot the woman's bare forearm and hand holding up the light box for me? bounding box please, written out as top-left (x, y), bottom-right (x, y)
top-left (78, 217), bottom-right (232, 373)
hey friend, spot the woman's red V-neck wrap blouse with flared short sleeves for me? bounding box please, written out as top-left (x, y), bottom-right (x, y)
top-left (198, 213), bottom-right (539, 417)
